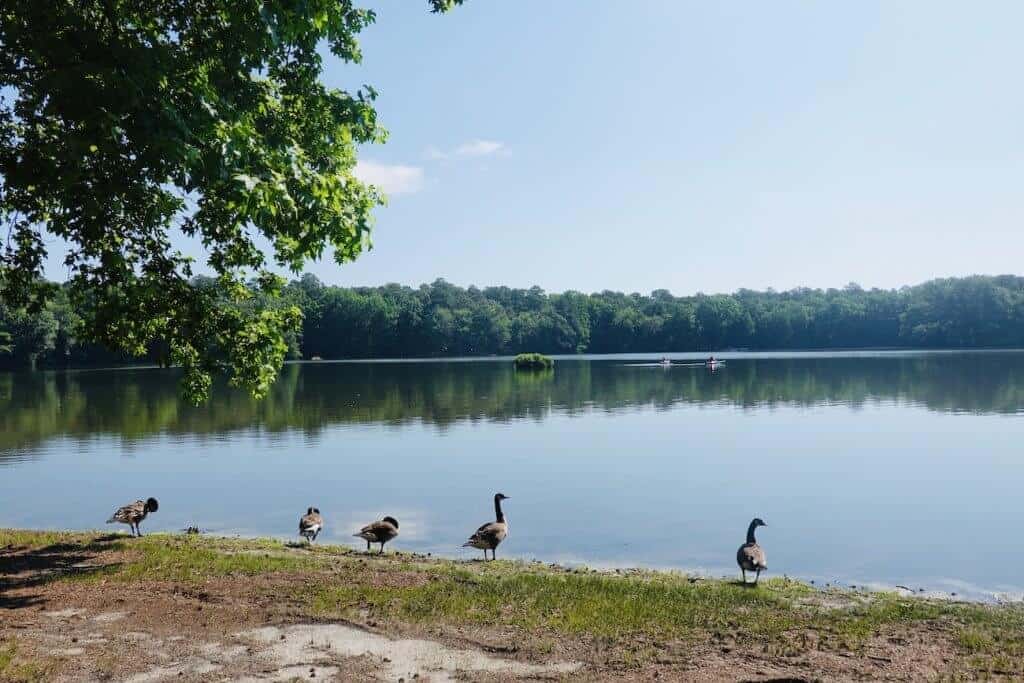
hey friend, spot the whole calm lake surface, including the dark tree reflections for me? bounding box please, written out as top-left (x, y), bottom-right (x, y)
top-left (0, 352), bottom-right (1024, 599)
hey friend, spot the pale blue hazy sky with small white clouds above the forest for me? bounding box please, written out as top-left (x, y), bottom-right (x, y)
top-left (54, 0), bottom-right (1024, 294)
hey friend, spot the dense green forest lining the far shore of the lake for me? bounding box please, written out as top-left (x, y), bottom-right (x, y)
top-left (0, 274), bottom-right (1024, 368)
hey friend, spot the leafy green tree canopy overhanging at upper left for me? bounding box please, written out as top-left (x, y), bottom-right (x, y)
top-left (0, 0), bottom-right (461, 399)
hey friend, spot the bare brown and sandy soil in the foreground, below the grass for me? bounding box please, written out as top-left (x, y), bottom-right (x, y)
top-left (0, 538), bottom-right (970, 683)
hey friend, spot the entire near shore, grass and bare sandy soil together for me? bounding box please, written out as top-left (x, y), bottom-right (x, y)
top-left (0, 529), bottom-right (1024, 681)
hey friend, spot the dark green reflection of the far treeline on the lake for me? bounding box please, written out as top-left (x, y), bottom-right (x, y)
top-left (0, 352), bottom-right (1024, 461)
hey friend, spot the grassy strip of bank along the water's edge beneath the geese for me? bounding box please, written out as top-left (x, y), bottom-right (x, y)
top-left (0, 530), bottom-right (1024, 675)
